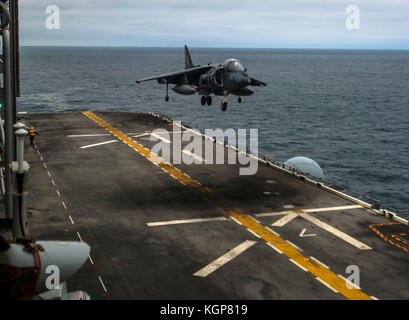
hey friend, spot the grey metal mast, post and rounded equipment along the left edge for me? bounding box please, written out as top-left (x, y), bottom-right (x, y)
top-left (0, 0), bottom-right (90, 300)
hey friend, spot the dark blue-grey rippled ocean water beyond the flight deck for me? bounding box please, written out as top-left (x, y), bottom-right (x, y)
top-left (18, 47), bottom-right (409, 217)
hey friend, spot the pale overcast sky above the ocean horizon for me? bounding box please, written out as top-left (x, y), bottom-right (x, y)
top-left (19, 0), bottom-right (409, 49)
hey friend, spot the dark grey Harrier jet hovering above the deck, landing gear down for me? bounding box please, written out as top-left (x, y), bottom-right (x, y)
top-left (136, 46), bottom-right (266, 111)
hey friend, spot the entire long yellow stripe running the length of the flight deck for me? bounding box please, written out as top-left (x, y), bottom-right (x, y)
top-left (84, 112), bottom-right (373, 300)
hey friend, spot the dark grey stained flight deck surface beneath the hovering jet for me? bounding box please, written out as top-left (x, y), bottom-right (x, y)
top-left (24, 112), bottom-right (409, 299)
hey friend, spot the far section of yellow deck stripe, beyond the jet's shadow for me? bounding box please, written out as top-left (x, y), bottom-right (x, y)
top-left (84, 112), bottom-right (209, 192)
